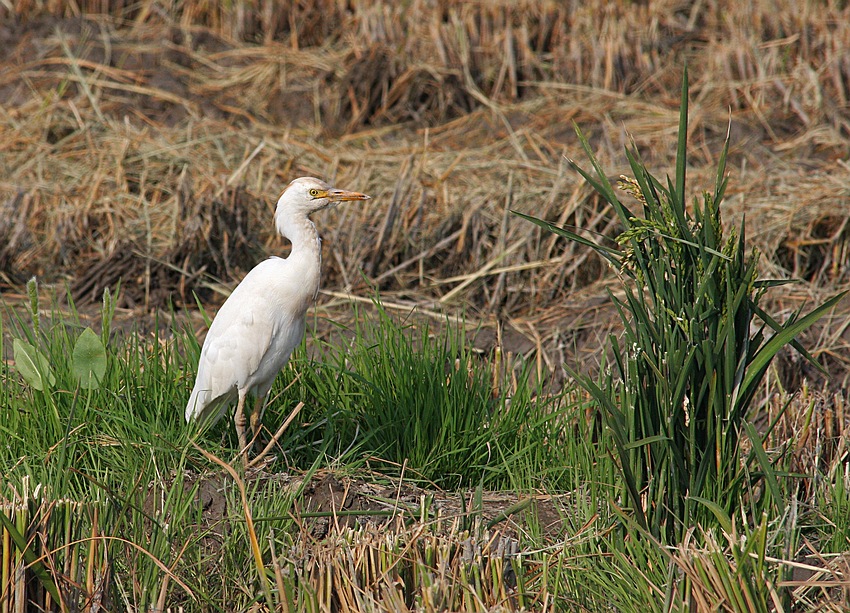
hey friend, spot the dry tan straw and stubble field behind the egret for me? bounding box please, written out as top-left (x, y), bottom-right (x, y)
top-left (0, 1), bottom-right (850, 316)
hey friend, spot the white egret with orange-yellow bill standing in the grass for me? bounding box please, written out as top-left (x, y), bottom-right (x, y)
top-left (186, 177), bottom-right (369, 459)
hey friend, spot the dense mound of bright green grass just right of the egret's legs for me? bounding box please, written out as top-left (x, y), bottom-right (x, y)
top-left (258, 298), bottom-right (574, 488)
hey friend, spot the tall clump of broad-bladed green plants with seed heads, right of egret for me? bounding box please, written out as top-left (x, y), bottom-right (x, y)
top-left (512, 71), bottom-right (844, 542)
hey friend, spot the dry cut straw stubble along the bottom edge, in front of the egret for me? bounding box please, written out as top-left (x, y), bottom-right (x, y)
top-left (6, 473), bottom-right (850, 611)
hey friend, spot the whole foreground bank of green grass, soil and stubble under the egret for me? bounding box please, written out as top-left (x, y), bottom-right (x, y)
top-left (0, 286), bottom-right (850, 611)
